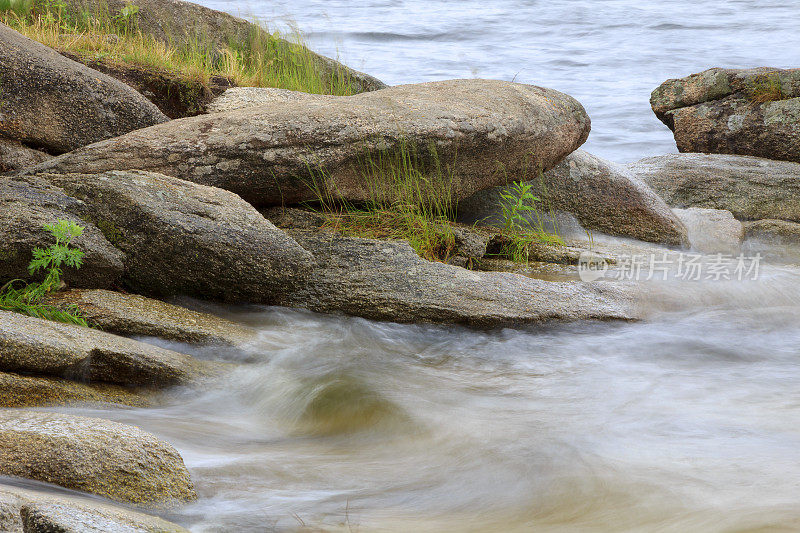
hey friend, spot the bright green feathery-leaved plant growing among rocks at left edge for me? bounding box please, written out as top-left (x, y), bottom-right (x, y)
top-left (0, 220), bottom-right (88, 326)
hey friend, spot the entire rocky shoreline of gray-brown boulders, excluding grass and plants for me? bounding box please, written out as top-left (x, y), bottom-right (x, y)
top-left (0, 0), bottom-right (800, 531)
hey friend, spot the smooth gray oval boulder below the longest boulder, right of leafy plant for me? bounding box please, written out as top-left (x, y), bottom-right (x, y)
top-left (37, 171), bottom-right (311, 302)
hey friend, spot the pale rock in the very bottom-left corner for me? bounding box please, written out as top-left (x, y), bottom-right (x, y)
top-left (0, 485), bottom-right (187, 533)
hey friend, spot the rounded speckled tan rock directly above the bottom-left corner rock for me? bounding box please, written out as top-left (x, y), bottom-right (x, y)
top-left (0, 410), bottom-right (197, 507)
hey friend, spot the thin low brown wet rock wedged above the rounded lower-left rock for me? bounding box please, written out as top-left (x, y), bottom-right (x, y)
top-left (0, 372), bottom-right (153, 408)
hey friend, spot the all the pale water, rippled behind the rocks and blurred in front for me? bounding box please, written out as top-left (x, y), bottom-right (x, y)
top-left (14, 0), bottom-right (800, 532)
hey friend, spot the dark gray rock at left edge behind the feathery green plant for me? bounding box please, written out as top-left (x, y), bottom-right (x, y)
top-left (0, 177), bottom-right (125, 287)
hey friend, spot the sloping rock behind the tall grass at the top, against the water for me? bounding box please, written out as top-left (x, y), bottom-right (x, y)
top-left (64, 0), bottom-right (386, 92)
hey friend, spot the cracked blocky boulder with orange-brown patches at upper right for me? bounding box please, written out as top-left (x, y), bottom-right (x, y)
top-left (650, 68), bottom-right (800, 162)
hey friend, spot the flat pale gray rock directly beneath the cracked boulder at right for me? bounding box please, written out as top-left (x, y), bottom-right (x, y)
top-left (628, 154), bottom-right (800, 222)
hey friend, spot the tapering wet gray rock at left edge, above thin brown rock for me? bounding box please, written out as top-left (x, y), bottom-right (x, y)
top-left (0, 311), bottom-right (213, 387)
